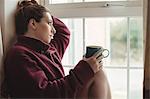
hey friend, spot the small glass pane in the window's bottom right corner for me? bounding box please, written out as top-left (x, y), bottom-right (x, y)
top-left (129, 69), bottom-right (143, 99)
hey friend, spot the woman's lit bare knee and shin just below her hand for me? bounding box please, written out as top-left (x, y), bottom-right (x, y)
top-left (88, 70), bottom-right (111, 99)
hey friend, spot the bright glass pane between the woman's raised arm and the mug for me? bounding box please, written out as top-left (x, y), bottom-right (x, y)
top-left (62, 19), bottom-right (83, 66)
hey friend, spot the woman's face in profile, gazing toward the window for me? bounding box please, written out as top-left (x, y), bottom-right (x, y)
top-left (35, 12), bottom-right (56, 43)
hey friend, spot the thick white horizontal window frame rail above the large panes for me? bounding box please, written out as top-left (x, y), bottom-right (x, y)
top-left (43, 0), bottom-right (143, 18)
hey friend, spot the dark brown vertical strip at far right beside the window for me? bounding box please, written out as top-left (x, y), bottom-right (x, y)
top-left (143, 0), bottom-right (150, 99)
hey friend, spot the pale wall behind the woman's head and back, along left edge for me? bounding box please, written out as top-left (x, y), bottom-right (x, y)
top-left (0, 0), bottom-right (18, 96)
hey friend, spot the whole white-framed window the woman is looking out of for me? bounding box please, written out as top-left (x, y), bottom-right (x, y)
top-left (45, 0), bottom-right (143, 99)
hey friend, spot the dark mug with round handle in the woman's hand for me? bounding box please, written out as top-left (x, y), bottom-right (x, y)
top-left (85, 46), bottom-right (109, 58)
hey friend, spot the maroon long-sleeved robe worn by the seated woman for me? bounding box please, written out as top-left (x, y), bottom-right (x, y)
top-left (4, 18), bottom-right (94, 98)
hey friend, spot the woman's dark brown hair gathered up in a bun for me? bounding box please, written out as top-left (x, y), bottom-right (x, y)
top-left (15, 0), bottom-right (49, 35)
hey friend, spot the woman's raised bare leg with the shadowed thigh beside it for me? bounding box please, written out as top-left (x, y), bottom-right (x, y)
top-left (77, 70), bottom-right (111, 99)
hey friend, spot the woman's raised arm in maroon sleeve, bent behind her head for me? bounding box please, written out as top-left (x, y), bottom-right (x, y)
top-left (50, 17), bottom-right (70, 58)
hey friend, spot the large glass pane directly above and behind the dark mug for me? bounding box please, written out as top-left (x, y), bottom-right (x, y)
top-left (85, 18), bottom-right (127, 66)
